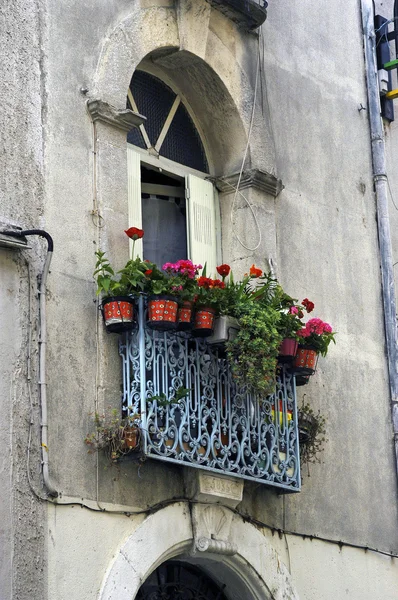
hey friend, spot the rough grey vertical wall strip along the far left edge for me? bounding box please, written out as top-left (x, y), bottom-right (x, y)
top-left (0, 0), bottom-right (46, 600)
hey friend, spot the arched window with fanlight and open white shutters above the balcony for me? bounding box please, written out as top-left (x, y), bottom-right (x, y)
top-left (127, 71), bottom-right (218, 273)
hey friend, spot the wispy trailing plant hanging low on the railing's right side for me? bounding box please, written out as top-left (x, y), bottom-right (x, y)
top-left (298, 403), bottom-right (327, 464)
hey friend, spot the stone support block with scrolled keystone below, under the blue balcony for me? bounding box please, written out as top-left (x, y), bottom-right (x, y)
top-left (186, 470), bottom-right (243, 555)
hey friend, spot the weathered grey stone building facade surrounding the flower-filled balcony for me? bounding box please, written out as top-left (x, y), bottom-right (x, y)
top-left (0, 0), bottom-right (398, 600)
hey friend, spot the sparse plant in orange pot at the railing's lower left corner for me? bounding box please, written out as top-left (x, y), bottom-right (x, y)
top-left (84, 409), bottom-right (141, 463)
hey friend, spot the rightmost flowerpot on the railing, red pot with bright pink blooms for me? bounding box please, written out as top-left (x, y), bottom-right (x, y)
top-left (293, 318), bottom-right (336, 376)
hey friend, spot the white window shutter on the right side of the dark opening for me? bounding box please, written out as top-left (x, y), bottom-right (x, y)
top-left (187, 175), bottom-right (217, 277)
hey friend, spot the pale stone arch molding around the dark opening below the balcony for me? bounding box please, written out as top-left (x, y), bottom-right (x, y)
top-left (98, 503), bottom-right (299, 600)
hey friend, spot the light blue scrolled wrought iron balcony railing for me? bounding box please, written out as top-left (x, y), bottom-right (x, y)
top-left (120, 296), bottom-right (300, 491)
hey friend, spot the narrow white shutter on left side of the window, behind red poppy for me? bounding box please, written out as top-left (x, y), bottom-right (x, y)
top-left (127, 146), bottom-right (142, 258)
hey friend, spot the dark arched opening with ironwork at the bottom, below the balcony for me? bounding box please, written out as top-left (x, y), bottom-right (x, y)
top-left (136, 560), bottom-right (227, 600)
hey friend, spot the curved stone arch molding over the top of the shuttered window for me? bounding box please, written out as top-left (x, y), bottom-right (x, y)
top-left (92, 0), bottom-right (275, 175)
